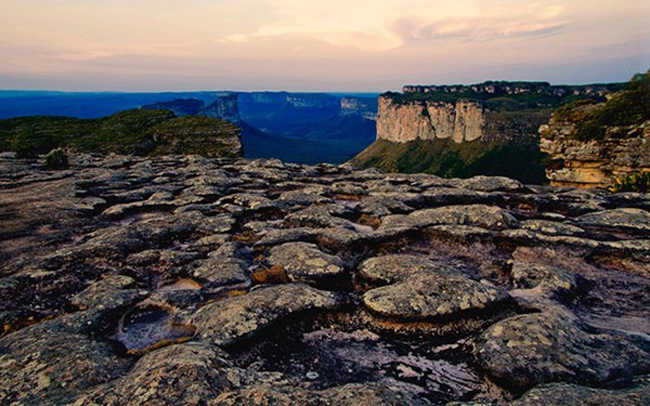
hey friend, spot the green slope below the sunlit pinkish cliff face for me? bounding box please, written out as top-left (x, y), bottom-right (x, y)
top-left (351, 138), bottom-right (547, 184)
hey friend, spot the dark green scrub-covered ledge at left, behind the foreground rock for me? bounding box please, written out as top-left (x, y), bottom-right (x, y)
top-left (0, 110), bottom-right (239, 158)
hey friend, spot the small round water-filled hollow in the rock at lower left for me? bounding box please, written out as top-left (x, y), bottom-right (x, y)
top-left (111, 306), bottom-right (196, 355)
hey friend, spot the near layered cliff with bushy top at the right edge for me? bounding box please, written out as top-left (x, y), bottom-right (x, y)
top-left (540, 73), bottom-right (650, 187)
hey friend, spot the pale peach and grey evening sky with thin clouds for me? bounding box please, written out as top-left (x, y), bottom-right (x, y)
top-left (0, 0), bottom-right (650, 92)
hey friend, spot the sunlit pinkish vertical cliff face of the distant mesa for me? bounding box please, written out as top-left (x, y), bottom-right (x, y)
top-left (377, 96), bottom-right (485, 143)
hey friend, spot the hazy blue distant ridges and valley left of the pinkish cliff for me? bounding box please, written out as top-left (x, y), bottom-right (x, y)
top-left (0, 91), bottom-right (377, 164)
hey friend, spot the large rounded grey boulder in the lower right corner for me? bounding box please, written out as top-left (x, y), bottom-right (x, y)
top-left (470, 309), bottom-right (650, 389)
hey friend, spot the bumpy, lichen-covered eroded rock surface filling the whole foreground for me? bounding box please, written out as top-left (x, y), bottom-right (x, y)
top-left (0, 155), bottom-right (650, 406)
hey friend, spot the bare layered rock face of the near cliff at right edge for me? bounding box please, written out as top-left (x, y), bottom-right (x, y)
top-left (540, 117), bottom-right (650, 188)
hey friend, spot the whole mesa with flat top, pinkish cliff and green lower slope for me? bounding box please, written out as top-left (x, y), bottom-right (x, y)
top-left (350, 81), bottom-right (625, 183)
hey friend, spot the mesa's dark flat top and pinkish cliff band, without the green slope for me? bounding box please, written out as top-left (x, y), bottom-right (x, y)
top-left (377, 81), bottom-right (620, 143)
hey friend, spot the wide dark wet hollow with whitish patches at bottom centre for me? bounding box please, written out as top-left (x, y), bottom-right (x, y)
top-left (235, 328), bottom-right (485, 403)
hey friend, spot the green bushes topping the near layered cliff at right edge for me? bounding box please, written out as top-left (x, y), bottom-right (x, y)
top-left (555, 70), bottom-right (650, 140)
